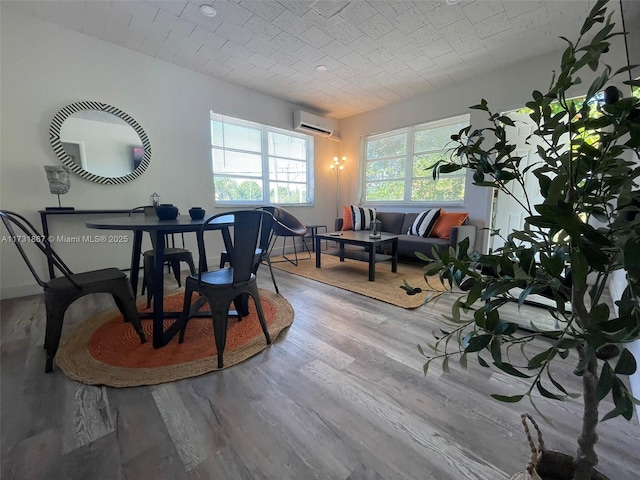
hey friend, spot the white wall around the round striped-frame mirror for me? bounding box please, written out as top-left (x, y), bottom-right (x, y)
top-left (0, 6), bottom-right (340, 298)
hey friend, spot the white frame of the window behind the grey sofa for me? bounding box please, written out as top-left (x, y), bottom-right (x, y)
top-left (359, 113), bottom-right (470, 206)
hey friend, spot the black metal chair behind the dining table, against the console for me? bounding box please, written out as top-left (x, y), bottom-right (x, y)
top-left (131, 206), bottom-right (196, 308)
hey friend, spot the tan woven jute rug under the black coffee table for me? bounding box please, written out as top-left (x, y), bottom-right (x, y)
top-left (271, 254), bottom-right (445, 308)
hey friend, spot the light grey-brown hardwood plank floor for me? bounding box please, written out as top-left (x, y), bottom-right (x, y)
top-left (0, 269), bottom-right (640, 480)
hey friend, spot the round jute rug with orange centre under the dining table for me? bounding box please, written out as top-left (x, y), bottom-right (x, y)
top-left (56, 289), bottom-right (294, 387)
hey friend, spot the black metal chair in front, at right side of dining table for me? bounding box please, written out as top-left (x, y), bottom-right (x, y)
top-left (179, 210), bottom-right (273, 368)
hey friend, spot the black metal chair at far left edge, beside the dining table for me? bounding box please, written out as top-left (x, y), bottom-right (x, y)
top-left (0, 210), bottom-right (146, 372)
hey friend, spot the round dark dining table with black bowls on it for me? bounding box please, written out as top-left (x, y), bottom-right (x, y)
top-left (85, 213), bottom-right (233, 348)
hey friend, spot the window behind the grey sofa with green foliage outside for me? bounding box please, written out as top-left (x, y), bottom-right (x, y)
top-left (362, 115), bottom-right (469, 205)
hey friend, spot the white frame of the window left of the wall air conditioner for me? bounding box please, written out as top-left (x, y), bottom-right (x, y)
top-left (209, 111), bottom-right (314, 206)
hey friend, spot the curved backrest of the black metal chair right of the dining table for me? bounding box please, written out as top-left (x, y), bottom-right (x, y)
top-left (198, 210), bottom-right (274, 283)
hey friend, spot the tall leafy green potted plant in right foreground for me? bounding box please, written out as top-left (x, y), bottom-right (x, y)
top-left (410, 0), bottom-right (640, 480)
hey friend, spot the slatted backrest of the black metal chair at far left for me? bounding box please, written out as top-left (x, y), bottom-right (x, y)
top-left (0, 210), bottom-right (80, 288)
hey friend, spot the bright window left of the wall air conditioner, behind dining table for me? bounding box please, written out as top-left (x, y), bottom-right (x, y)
top-left (211, 112), bottom-right (313, 205)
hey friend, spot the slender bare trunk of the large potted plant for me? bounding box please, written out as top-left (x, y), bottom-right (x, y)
top-left (572, 286), bottom-right (600, 480)
